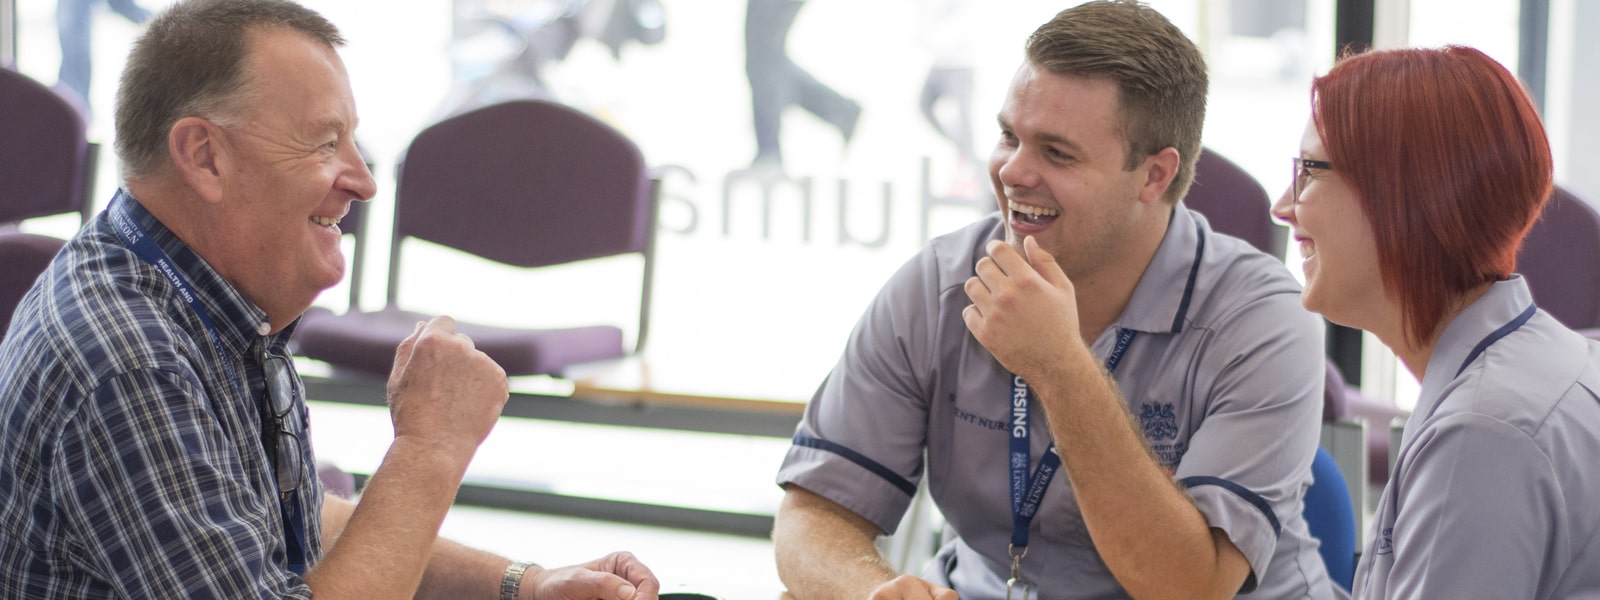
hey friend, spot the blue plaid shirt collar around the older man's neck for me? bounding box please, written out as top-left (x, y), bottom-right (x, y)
top-left (112, 189), bottom-right (278, 354)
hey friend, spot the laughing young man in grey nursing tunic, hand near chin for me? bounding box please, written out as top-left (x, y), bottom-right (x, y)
top-left (773, 2), bottom-right (1338, 598)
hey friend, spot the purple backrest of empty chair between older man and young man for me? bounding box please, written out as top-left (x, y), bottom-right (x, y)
top-left (387, 99), bottom-right (659, 352)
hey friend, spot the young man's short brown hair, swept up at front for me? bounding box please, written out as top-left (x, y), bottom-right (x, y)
top-left (1026, 0), bottom-right (1208, 202)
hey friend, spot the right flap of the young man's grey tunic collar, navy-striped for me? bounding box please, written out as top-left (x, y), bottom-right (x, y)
top-left (1117, 202), bottom-right (1211, 333)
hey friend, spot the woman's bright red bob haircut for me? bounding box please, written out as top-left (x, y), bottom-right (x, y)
top-left (1312, 46), bottom-right (1552, 342)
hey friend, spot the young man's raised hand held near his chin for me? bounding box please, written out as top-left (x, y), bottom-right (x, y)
top-left (962, 235), bottom-right (1088, 381)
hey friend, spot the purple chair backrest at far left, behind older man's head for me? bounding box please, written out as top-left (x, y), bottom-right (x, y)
top-left (0, 69), bottom-right (94, 222)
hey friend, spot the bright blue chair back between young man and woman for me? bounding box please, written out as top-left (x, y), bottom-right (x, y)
top-left (1302, 446), bottom-right (1355, 590)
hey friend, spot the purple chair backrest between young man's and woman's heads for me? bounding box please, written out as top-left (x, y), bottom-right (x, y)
top-left (1184, 149), bottom-right (1288, 261)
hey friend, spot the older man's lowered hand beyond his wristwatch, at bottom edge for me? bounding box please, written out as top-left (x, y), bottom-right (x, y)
top-left (518, 552), bottom-right (661, 600)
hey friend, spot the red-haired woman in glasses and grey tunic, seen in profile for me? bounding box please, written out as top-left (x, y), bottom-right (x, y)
top-left (1272, 46), bottom-right (1600, 598)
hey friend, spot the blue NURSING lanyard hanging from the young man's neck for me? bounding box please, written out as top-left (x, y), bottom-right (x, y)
top-left (1005, 330), bottom-right (1138, 600)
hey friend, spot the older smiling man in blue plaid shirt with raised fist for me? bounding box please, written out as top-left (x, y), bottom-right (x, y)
top-left (0, 0), bottom-right (659, 598)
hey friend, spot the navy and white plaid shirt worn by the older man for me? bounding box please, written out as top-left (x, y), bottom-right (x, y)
top-left (0, 192), bottom-right (322, 598)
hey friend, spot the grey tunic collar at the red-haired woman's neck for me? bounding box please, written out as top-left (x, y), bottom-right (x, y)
top-left (1416, 274), bottom-right (1533, 414)
